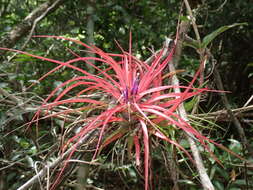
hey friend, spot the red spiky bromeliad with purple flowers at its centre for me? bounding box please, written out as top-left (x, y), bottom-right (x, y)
top-left (1, 36), bottom-right (223, 190)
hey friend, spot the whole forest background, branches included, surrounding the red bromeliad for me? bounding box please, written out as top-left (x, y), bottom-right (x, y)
top-left (0, 0), bottom-right (253, 190)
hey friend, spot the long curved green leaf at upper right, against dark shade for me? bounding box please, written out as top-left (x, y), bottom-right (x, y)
top-left (201, 22), bottom-right (248, 48)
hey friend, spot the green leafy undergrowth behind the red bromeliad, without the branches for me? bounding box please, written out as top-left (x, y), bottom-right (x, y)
top-left (0, 0), bottom-right (253, 190)
